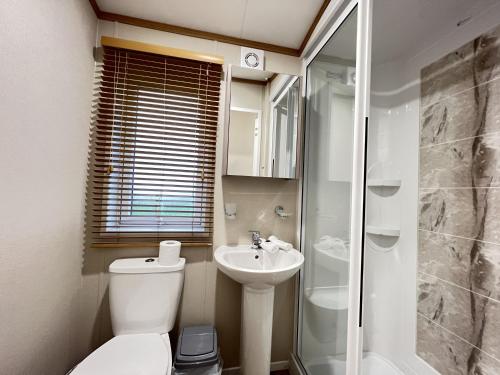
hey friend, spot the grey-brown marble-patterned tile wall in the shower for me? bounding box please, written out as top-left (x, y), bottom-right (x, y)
top-left (417, 27), bottom-right (500, 375)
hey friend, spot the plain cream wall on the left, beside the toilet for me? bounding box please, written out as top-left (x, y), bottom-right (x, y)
top-left (0, 0), bottom-right (96, 375)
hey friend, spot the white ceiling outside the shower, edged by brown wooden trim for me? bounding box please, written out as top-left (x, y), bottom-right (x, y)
top-left (97, 0), bottom-right (323, 48)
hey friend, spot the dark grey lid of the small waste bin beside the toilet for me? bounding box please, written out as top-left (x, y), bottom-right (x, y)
top-left (175, 325), bottom-right (219, 368)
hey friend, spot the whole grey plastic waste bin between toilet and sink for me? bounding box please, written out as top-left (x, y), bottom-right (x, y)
top-left (172, 326), bottom-right (222, 375)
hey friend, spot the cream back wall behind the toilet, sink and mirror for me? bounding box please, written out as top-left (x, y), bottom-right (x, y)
top-left (82, 21), bottom-right (300, 367)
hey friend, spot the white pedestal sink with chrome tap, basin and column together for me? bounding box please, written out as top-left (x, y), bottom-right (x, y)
top-left (214, 245), bottom-right (304, 375)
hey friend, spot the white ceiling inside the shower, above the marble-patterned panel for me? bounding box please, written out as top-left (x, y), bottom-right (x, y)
top-left (321, 0), bottom-right (500, 64)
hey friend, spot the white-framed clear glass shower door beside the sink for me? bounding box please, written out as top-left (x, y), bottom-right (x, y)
top-left (297, 2), bottom-right (367, 375)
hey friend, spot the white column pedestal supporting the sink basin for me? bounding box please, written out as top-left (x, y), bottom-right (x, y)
top-left (240, 285), bottom-right (274, 375)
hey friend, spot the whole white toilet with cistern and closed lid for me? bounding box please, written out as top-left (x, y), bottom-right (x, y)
top-left (70, 258), bottom-right (185, 375)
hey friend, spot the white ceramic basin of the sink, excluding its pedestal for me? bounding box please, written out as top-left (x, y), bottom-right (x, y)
top-left (214, 245), bottom-right (304, 289)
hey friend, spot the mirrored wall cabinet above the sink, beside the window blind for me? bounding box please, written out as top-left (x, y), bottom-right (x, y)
top-left (223, 66), bottom-right (301, 179)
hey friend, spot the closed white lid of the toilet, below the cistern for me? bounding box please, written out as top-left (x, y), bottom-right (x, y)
top-left (70, 333), bottom-right (172, 375)
